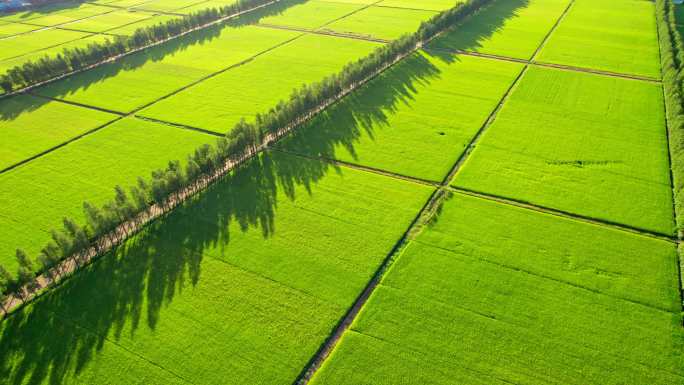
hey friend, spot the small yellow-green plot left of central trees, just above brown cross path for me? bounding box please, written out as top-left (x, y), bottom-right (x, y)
top-left (325, 7), bottom-right (437, 40)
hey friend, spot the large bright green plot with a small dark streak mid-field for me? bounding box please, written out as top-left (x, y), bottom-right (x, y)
top-left (454, 68), bottom-right (673, 234)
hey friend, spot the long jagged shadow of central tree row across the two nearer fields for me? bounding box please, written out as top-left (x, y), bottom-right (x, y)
top-left (0, 1), bottom-right (528, 384)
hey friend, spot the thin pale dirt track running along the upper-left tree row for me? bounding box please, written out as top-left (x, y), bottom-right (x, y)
top-left (0, 0), bottom-right (283, 100)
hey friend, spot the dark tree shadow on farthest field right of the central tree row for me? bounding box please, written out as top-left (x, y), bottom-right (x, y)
top-left (427, 0), bottom-right (530, 62)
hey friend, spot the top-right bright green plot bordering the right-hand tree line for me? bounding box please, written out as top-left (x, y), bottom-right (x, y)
top-left (538, 0), bottom-right (660, 78)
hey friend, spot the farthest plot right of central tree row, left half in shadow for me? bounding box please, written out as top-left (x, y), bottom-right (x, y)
top-left (430, 0), bottom-right (569, 59)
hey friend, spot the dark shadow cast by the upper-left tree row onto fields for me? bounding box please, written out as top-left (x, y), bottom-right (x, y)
top-left (0, 0), bottom-right (309, 123)
